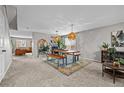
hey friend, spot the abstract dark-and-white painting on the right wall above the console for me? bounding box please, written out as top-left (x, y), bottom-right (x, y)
top-left (111, 30), bottom-right (124, 47)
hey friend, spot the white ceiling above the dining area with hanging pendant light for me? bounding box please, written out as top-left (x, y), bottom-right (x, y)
top-left (15, 5), bottom-right (124, 34)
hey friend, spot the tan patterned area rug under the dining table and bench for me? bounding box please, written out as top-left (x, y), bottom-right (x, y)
top-left (45, 60), bottom-right (91, 76)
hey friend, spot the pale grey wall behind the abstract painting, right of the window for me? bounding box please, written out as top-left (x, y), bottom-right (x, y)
top-left (78, 23), bottom-right (124, 61)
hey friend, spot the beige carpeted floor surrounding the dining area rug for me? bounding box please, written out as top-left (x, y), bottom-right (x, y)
top-left (0, 57), bottom-right (124, 87)
